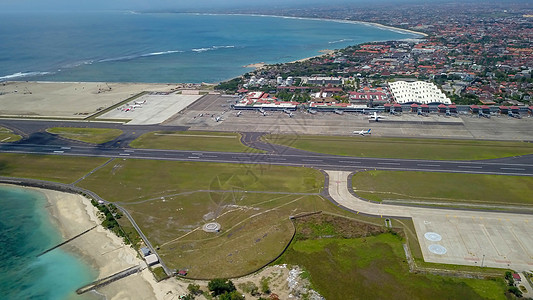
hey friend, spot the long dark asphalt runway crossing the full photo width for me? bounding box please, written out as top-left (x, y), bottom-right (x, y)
top-left (0, 143), bottom-right (533, 176)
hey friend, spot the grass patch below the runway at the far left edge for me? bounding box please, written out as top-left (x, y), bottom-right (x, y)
top-left (0, 153), bottom-right (108, 183)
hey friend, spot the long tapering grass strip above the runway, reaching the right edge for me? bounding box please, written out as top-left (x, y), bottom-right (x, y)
top-left (263, 135), bottom-right (533, 160)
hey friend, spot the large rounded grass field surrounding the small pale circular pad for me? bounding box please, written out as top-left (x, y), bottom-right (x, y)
top-left (79, 160), bottom-right (326, 278)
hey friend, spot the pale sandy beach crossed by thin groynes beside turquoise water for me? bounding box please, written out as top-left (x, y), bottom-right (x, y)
top-left (26, 189), bottom-right (187, 299)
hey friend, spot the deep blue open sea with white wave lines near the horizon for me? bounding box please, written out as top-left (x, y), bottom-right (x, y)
top-left (0, 12), bottom-right (417, 83)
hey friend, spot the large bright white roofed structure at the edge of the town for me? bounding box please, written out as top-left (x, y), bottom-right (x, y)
top-left (389, 81), bottom-right (452, 104)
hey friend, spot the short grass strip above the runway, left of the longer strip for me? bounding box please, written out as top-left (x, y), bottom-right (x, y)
top-left (130, 131), bottom-right (254, 152)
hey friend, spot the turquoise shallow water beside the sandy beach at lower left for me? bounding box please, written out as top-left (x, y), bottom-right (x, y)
top-left (0, 186), bottom-right (97, 300)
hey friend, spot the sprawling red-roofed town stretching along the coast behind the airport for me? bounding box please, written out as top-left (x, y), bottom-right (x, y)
top-left (217, 2), bottom-right (533, 117)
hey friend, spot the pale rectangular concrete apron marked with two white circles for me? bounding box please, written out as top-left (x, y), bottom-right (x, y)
top-left (413, 210), bottom-right (533, 270)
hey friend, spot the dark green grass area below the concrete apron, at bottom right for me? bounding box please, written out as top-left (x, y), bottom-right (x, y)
top-left (278, 234), bottom-right (505, 300)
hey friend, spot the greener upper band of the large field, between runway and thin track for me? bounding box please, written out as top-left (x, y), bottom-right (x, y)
top-left (80, 159), bottom-right (324, 202)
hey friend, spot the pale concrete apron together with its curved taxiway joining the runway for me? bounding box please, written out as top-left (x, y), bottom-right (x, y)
top-left (326, 171), bottom-right (533, 271)
